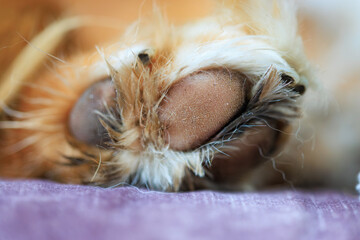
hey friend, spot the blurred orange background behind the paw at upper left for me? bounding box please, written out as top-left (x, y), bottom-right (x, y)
top-left (0, 0), bottom-right (214, 79)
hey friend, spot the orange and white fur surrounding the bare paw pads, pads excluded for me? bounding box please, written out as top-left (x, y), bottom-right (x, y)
top-left (0, 0), bottom-right (358, 191)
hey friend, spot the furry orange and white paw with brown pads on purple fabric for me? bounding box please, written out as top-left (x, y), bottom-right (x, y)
top-left (0, 0), bottom-right (360, 191)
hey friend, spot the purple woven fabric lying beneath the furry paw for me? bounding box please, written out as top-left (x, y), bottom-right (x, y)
top-left (0, 181), bottom-right (360, 240)
